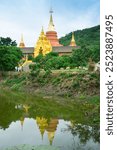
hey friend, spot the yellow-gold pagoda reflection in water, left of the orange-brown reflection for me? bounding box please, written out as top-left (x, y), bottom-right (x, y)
top-left (36, 117), bottom-right (48, 139)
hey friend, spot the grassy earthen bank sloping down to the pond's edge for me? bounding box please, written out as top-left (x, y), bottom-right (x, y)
top-left (0, 70), bottom-right (100, 98)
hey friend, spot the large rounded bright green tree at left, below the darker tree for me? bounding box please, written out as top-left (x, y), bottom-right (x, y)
top-left (0, 46), bottom-right (22, 71)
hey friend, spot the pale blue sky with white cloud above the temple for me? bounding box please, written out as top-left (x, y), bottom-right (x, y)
top-left (0, 0), bottom-right (100, 47)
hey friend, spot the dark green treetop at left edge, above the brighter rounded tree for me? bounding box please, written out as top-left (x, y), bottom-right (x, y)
top-left (0, 37), bottom-right (17, 46)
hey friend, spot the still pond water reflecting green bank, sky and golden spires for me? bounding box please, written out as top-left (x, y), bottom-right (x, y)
top-left (0, 92), bottom-right (99, 150)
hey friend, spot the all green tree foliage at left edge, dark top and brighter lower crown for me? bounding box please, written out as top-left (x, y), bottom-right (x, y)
top-left (0, 37), bottom-right (22, 71)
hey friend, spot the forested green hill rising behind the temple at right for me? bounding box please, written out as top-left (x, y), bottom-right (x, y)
top-left (59, 25), bottom-right (100, 47)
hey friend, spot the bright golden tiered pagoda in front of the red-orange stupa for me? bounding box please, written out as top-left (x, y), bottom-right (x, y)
top-left (34, 28), bottom-right (52, 57)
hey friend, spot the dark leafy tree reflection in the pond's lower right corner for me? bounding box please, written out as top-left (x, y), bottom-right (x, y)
top-left (68, 123), bottom-right (100, 144)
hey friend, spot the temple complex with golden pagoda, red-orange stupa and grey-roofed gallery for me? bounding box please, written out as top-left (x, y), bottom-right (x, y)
top-left (19, 9), bottom-right (79, 58)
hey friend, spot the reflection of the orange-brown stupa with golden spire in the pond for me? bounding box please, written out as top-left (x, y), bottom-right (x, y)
top-left (46, 119), bottom-right (58, 145)
